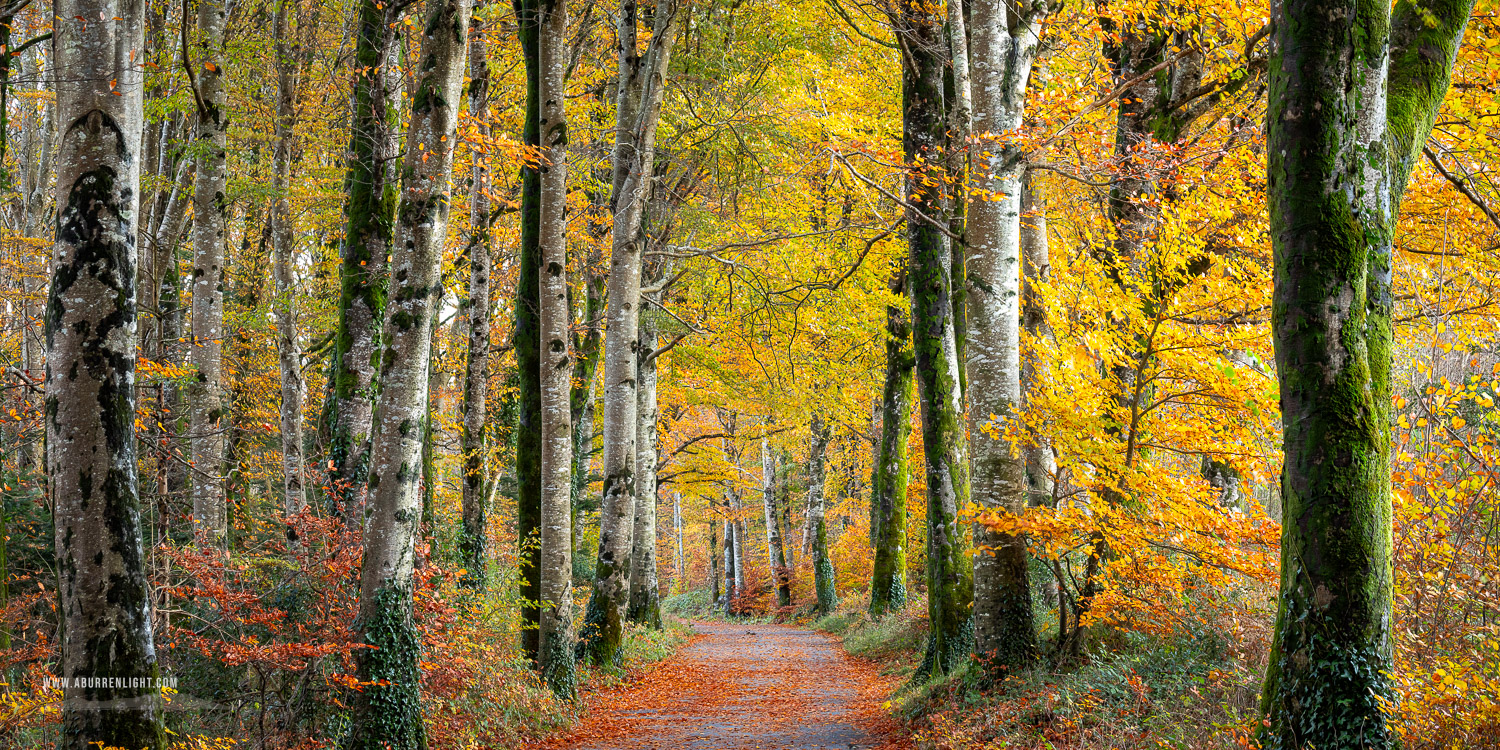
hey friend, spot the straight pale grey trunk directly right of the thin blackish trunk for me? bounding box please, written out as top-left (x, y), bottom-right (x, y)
top-left (537, 0), bottom-right (578, 699)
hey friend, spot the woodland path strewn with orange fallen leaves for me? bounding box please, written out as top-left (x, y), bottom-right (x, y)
top-left (546, 623), bottom-right (908, 750)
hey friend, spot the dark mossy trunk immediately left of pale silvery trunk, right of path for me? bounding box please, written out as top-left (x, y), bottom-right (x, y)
top-left (897, 0), bottom-right (974, 675)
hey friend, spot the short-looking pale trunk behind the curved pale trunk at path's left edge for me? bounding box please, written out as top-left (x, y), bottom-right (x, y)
top-left (629, 327), bottom-right (662, 630)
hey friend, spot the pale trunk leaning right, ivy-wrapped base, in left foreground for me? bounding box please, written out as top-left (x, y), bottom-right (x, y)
top-left (345, 0), bottom-right (471, 741)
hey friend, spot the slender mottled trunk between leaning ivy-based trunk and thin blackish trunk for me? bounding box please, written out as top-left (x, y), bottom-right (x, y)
top-left (459, 8), bottom-right (491, 587)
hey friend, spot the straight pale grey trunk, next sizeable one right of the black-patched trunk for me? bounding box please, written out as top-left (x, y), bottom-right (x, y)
top-left (188, 0), bottom-right (230, 548)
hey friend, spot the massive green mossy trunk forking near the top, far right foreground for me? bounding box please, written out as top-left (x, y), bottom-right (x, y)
top-left (1262, 0), bottom-right (1473, 750)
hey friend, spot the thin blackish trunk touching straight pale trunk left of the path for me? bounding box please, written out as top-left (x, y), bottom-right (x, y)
top-left (512, 0), bottom-right (542, 662)
